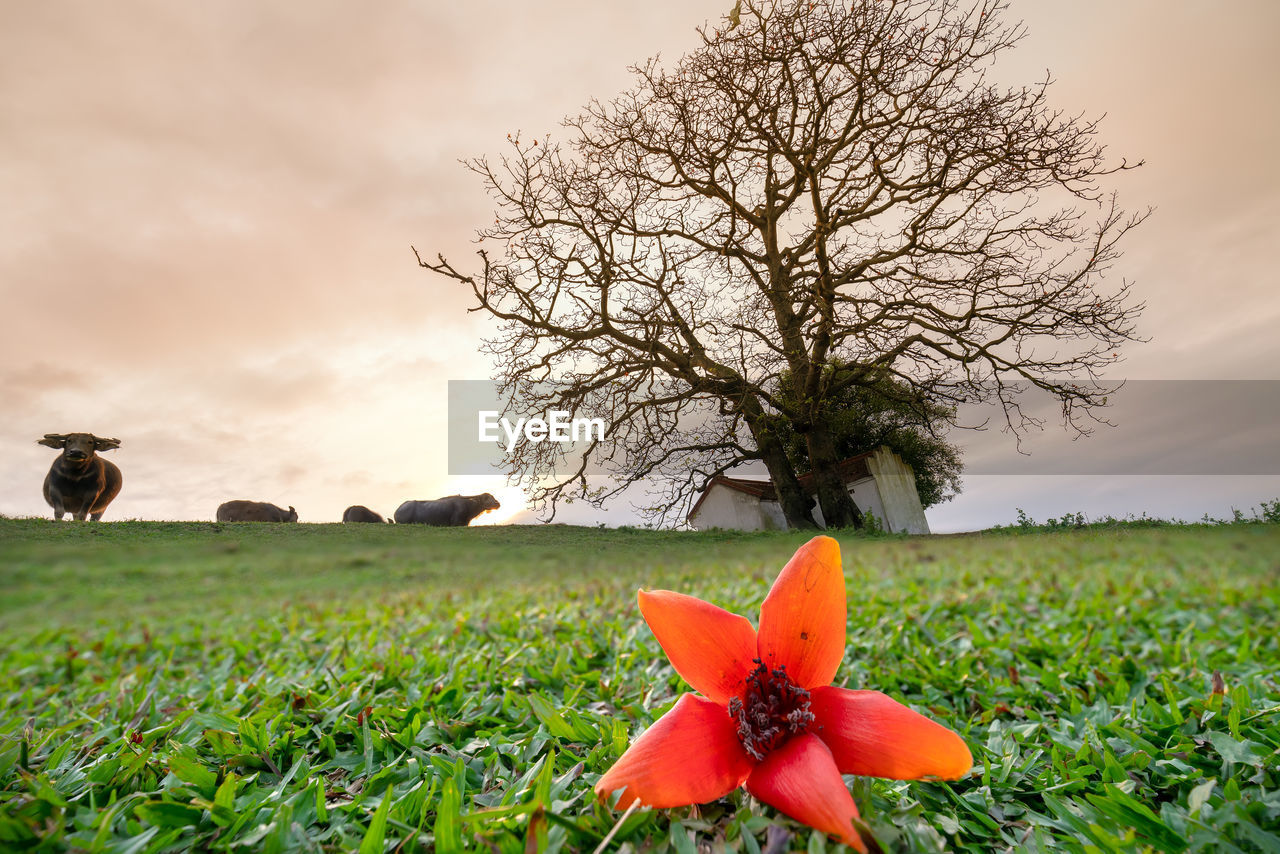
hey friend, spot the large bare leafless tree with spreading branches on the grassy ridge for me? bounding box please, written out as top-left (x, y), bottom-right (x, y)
top-left (420, 0), bottom-right (1146, 526)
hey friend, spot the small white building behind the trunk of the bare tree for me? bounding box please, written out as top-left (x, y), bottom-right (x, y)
top-left (685, 446), bottom-right (929, 534)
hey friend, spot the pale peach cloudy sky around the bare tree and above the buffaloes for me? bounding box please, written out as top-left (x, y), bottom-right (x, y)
top-left (0, 0), bottom-right (1280, 531)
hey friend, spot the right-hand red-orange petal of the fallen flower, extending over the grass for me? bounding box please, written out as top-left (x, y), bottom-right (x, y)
top-left (809, 686), bottom-right (973, 780)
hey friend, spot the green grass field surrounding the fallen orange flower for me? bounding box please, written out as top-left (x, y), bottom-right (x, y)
top-left (0, 519), bottom-right (1280, 854)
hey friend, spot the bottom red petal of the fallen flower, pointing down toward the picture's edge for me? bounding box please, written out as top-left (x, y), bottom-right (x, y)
top-left (746, 732), bottom-right (867, 851)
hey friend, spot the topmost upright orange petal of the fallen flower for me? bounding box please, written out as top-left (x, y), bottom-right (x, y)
top-left (758, 536), bottom-right (846, 688)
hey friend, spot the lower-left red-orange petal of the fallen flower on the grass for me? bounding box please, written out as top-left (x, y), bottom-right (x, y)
top-left (595, 694), bottom-right (753, 809)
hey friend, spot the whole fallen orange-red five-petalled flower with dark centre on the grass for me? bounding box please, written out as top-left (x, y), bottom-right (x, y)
top-left (595, 536), bottom-right (973, 851)
